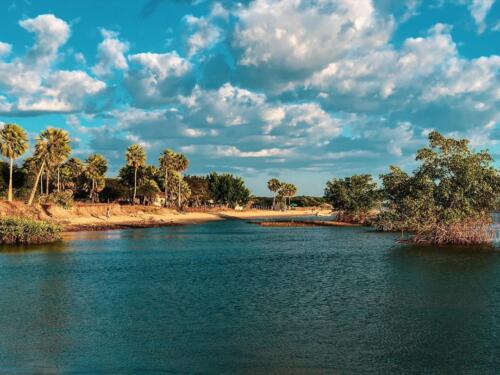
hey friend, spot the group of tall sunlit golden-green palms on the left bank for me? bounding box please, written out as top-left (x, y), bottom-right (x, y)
top-left (0, 124), bottom-right (193, 207)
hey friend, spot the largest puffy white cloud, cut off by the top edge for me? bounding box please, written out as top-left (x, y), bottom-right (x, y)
top-left (233, 0), bottom-right (393, 89)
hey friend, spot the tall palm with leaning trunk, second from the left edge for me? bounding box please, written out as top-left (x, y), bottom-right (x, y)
top-left (28, 128), bottom-right (71, 205)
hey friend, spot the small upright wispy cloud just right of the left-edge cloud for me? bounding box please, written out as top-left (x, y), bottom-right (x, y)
top-left (92, 29), bottom-right (129, 76)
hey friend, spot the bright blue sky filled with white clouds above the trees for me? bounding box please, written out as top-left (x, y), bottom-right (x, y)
top-left (0, 0), bottom-right (500, 195)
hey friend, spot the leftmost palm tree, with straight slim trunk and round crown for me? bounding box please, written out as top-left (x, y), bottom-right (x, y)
top-left (0, 124), bottom-right (28, 202)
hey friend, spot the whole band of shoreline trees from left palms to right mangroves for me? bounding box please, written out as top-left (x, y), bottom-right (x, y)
top-left (0, 124), bottom-right (500, 248)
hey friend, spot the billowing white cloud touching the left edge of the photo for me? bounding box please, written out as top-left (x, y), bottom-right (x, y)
top-left (0, 14), bottom-right (106, 115)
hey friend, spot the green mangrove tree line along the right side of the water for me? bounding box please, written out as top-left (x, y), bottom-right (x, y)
top-left (325, 131), bottom-right (500, 244)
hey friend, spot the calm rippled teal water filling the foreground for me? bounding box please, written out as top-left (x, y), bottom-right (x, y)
top-left (0, 221), bottom-right (500, 374)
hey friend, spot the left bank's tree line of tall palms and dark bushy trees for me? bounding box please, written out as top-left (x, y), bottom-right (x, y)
top-left (0, 124), bottom-right (251, 208)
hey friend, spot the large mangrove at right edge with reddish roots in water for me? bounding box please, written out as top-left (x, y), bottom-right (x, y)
top-left (375, 132), bottom-right (500, 244)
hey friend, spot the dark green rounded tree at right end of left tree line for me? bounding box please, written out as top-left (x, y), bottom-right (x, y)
top-left (207, 172), bottom-right (250, 207)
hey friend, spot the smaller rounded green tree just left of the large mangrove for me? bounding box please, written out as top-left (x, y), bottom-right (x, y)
top-left (325, 175), bottom-right (381, 222)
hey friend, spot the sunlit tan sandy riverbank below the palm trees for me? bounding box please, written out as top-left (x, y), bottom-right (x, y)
top-left (0, 202), bottom-right (328, 232)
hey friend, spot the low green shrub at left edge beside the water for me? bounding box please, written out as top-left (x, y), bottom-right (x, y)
top-left (0, 217), bottom-right (61, 245)
